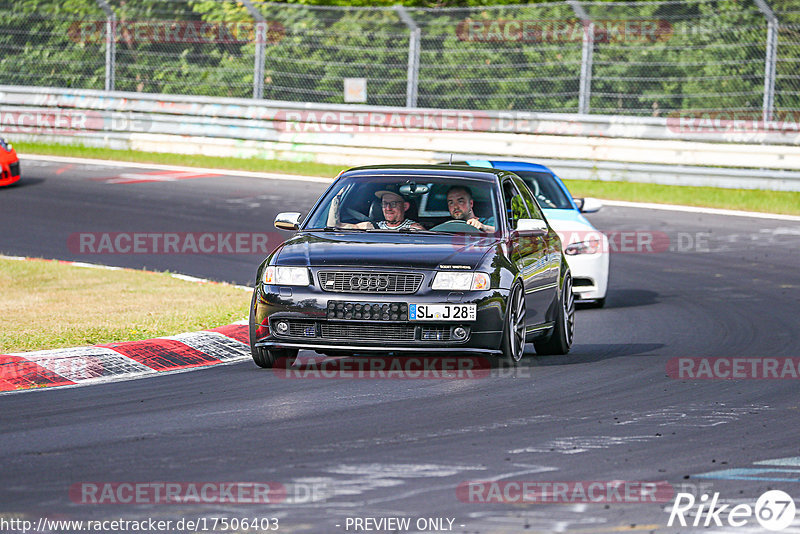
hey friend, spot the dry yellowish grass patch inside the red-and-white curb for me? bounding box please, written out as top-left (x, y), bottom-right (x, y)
top-left (0, 258), bottom-right (250, 354)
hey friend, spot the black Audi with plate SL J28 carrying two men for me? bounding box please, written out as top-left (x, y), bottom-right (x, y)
top-left (250, 165), bottom-right (575, 367)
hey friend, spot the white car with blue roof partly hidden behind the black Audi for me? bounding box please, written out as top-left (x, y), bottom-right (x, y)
top-left (460, 160), bottom-right (609, 308)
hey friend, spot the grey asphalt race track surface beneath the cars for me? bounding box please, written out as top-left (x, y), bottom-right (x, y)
top-left (0, 159), bottom-right (800, 533)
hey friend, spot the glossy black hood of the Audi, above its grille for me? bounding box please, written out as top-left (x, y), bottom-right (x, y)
top-left (274, 232), bottom-right (499, 269)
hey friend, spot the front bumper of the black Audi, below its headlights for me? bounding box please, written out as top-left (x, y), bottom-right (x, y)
top-left (251, 284), bottom-right (508, 353)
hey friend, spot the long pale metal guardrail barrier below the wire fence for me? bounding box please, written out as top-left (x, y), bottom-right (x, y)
top-left (0, 86), bottom-right (800, 191)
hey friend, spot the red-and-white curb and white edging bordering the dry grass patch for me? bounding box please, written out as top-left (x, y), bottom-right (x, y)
top-left (0, 256), bottom-right (252, 394)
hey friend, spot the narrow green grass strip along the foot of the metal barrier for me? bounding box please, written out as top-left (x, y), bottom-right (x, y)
top-left (15, 142), bottom-right (800, 215)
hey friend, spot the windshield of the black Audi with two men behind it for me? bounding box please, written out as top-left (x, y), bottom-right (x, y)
top-left (303, 176), bottom-right (498, 234)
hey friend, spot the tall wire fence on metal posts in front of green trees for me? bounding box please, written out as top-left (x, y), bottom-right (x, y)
top-left (0, 0), bottom-right (800, 118)
